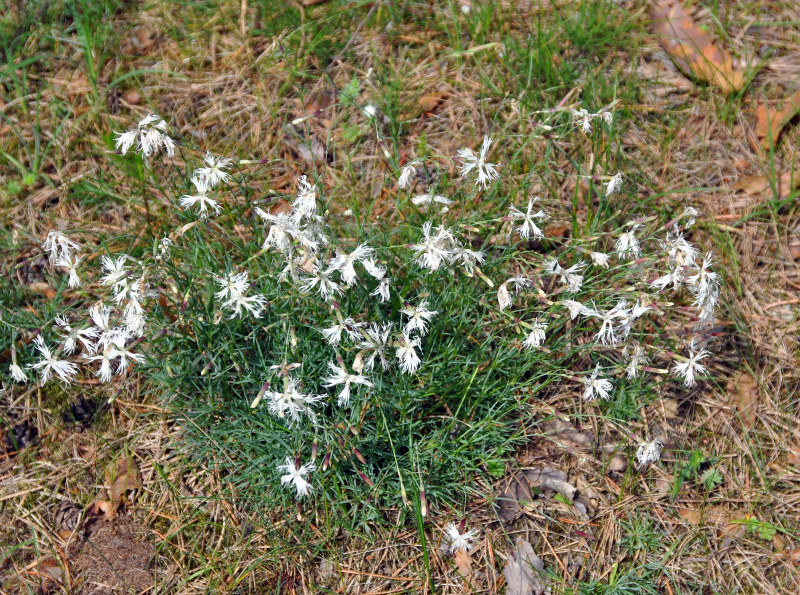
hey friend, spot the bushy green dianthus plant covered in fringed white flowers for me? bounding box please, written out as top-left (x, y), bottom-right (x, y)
top-left (3, 103), bottom-right (720, 507)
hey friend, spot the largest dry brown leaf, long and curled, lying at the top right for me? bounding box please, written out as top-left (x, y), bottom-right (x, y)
top-left (650, 0), bottom-right (745, 93)
